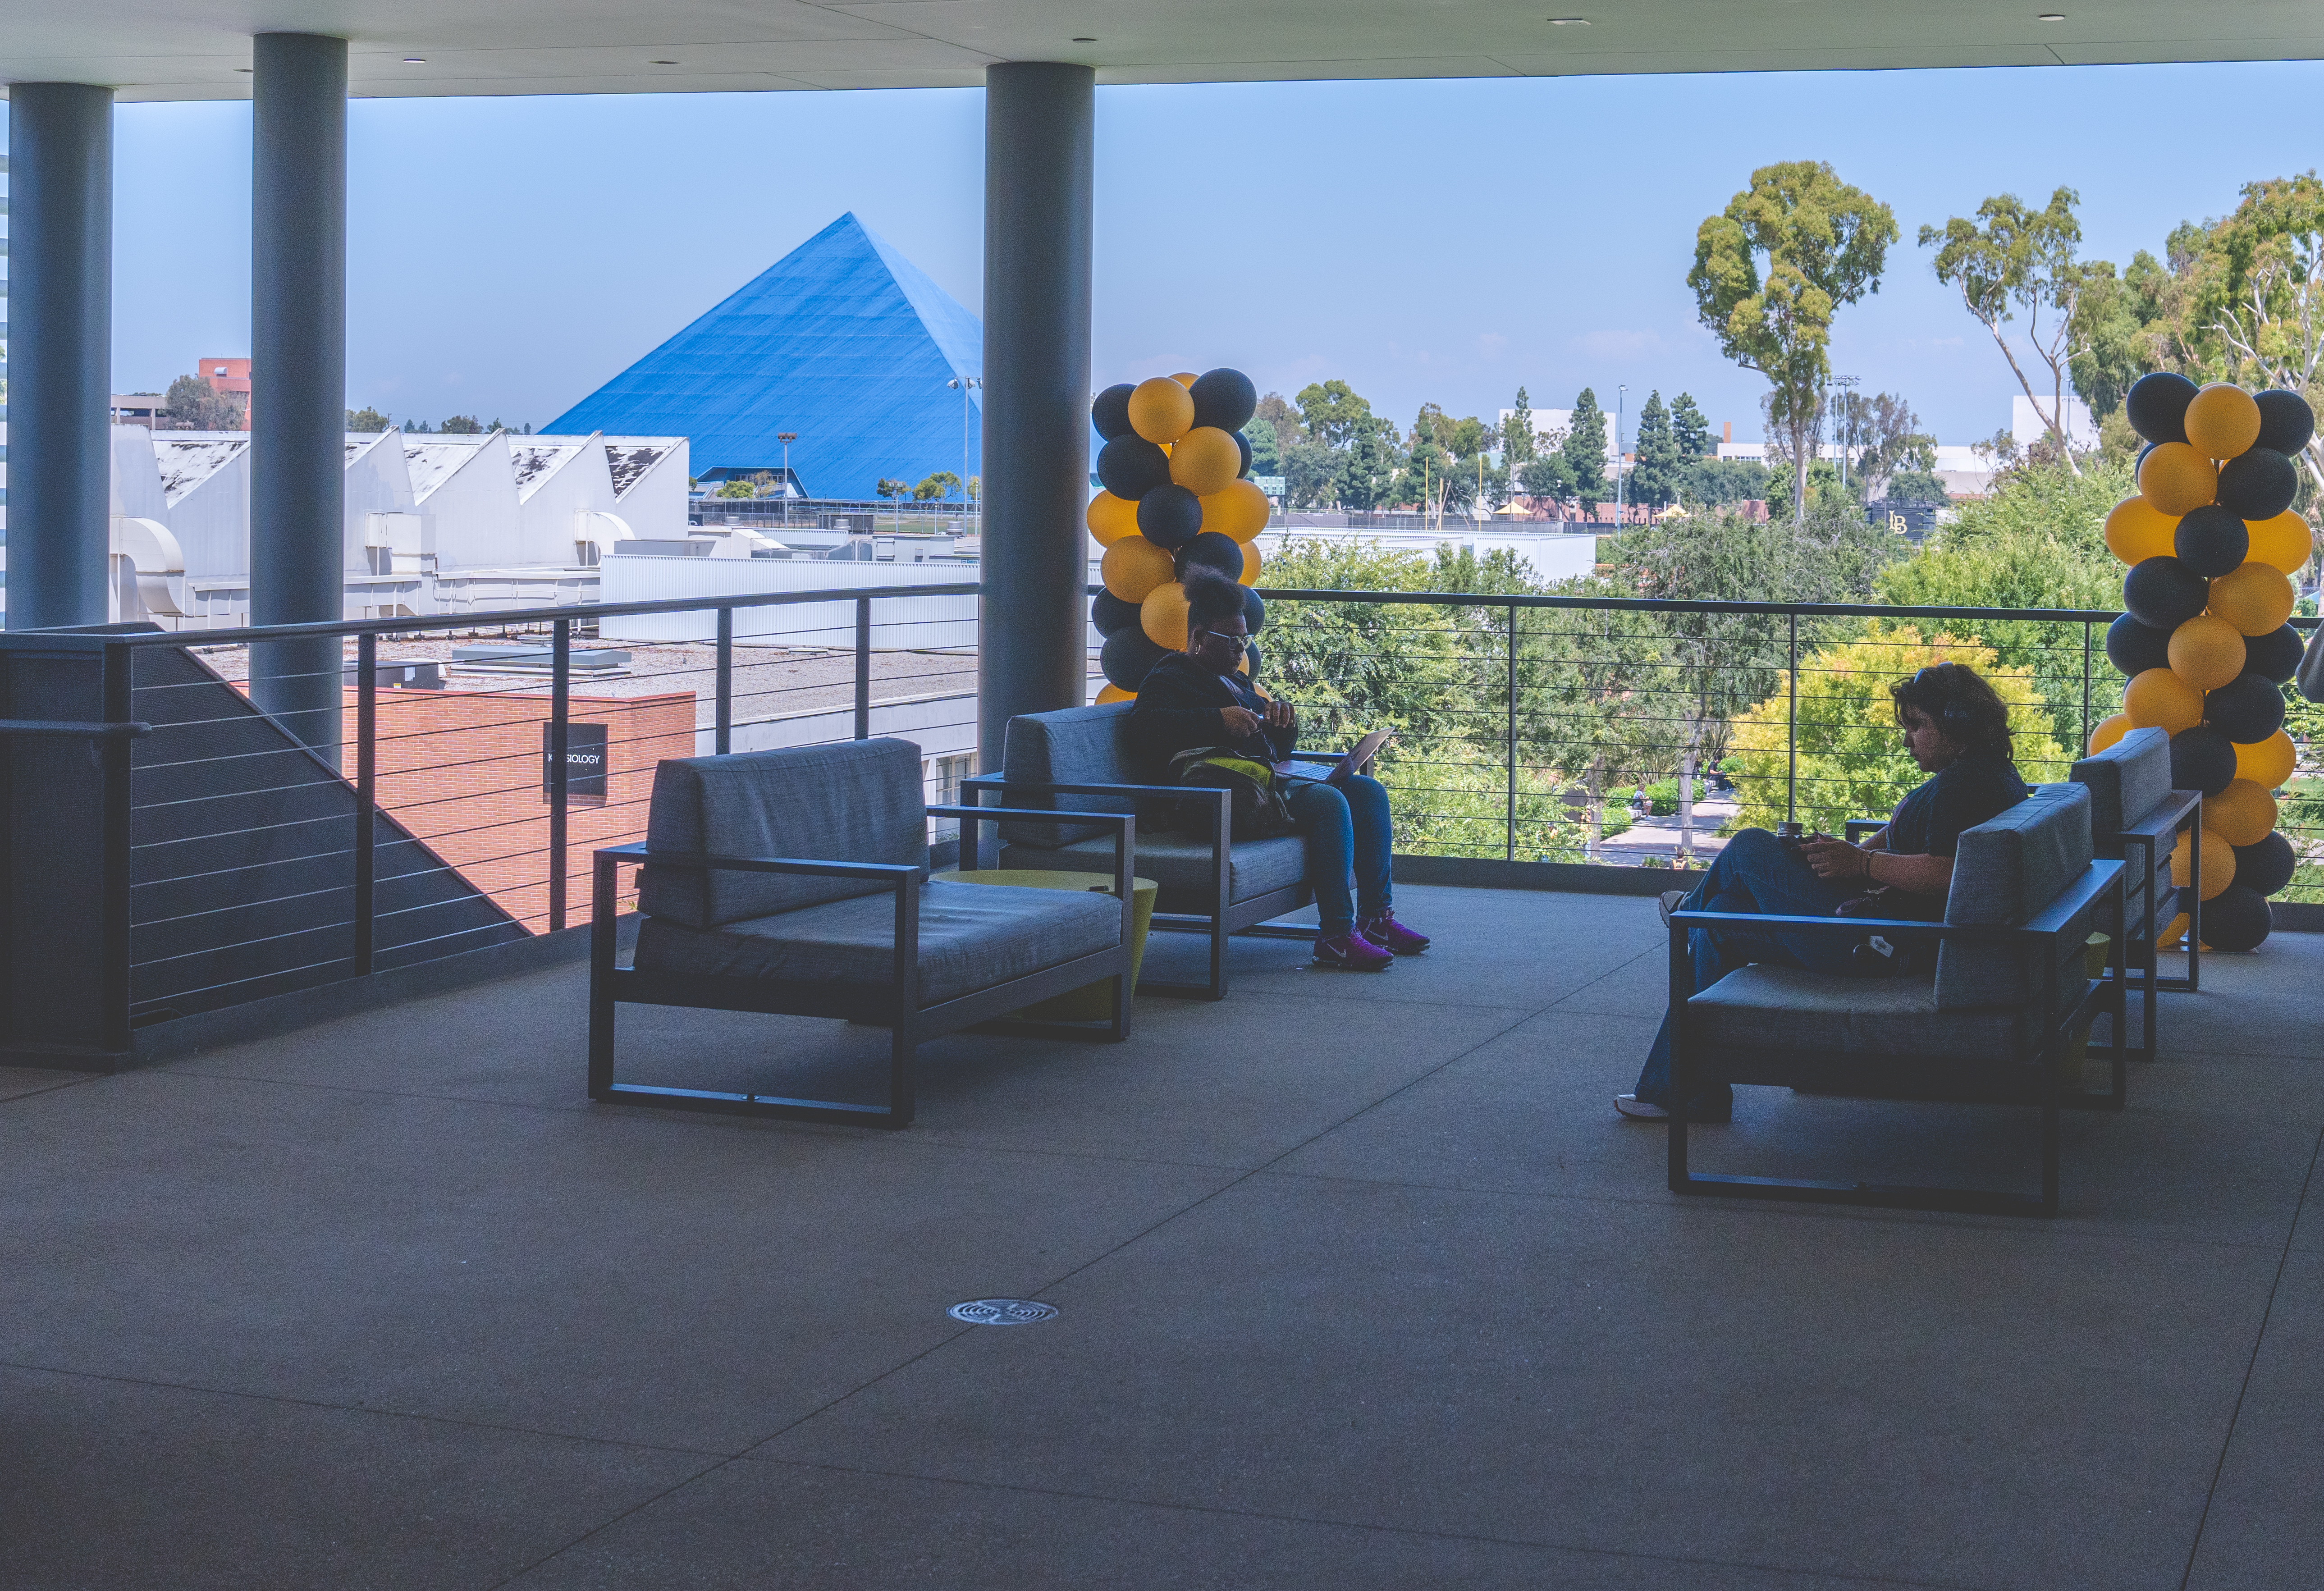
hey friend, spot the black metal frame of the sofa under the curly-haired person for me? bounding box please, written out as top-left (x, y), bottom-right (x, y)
top-left (1669, 862), bottom-right (2127, 1215)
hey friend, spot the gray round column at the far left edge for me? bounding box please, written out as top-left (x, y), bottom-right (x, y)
top-left (7, 84), bottom-right (114, 630)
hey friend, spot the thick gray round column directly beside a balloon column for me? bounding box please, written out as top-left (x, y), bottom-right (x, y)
top-left (976, 60), bottom-right (1097, 773)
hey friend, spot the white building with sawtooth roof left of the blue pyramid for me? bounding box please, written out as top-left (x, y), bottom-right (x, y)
top-left (111, 425), bottom-right (697, 630)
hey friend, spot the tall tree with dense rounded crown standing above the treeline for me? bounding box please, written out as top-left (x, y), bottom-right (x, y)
top-left (1687, 160), bottom-right (1896, 518)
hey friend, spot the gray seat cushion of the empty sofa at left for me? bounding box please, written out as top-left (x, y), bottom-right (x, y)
top-left (637, 878), bottom-right (1122, 1006)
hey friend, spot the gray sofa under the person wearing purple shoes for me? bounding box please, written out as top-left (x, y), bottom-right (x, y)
top-left (960, 701), bottom-right (1339, 999)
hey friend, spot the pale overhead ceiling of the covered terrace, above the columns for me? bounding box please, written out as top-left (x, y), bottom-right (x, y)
top-left (0, 0), bottom-right (2324, 100)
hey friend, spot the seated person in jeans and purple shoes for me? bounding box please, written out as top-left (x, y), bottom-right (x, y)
top-left (1130, 564), bottom-right (1429, 973)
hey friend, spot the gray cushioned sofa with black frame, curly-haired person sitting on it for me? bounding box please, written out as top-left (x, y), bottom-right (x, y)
top-left (1669, 785), bottom-right (2124, 1215)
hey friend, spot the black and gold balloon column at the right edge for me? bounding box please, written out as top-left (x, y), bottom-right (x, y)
top-left (2089, 374), bottom-right (2315, 950)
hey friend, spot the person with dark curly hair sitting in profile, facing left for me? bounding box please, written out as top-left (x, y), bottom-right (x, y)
top-left (1613, 662), bottom-right (2031, 1122)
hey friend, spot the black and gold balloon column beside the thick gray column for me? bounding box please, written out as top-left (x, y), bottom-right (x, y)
top-left (1088, 369), bottom-right (1269, 701)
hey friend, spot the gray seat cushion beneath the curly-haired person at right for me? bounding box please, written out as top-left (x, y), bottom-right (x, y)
top-left (1687, 966), bottom-right (2080, 1061)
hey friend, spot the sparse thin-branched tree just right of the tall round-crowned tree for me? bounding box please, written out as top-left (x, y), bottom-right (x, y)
top-left (1920, 188), bottom-right (2085, 469)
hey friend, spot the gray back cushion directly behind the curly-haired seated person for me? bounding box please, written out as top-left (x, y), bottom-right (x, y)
top-left (1936, 785), bottom-right (2089, 1010)
